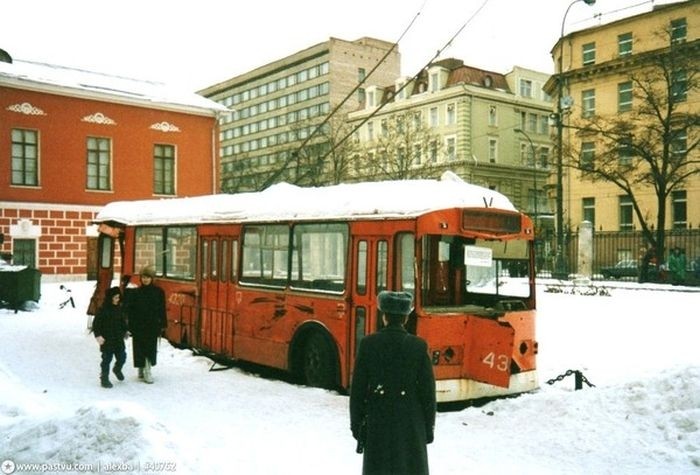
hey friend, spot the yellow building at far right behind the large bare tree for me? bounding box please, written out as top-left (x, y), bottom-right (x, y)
top-left (545, 0), bottom-right (700, 234)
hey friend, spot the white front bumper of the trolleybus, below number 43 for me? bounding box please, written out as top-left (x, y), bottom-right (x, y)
top-left (435, 371), bottom-right (539, 402)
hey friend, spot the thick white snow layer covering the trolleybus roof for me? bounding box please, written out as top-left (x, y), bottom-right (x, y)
top-left (95, 172), bottom-right (516, 225)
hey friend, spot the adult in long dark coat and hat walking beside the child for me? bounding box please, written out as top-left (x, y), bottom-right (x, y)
top-left (127, 266), bottom-right (167, 384)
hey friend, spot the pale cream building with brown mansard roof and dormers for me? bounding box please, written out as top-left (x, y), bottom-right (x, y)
top-left (348, 59), bottom-right (552, 230)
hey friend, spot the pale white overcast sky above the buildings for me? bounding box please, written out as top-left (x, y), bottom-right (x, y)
top-left (0, 0), bottom-right (670, 91)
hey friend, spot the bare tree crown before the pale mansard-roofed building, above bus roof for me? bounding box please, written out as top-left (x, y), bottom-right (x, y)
top-left (359, 111), bottom-right (442, 180)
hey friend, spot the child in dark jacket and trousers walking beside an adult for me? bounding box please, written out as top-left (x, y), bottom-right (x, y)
top-left (92, 287), bottom-right (128, 388)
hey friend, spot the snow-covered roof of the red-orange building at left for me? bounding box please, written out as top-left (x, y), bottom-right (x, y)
top-left (0, 60), bottom-right (229, 115)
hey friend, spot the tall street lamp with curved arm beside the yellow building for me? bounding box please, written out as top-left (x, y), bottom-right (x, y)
top-left (553, 0), bottom-right (596, 279)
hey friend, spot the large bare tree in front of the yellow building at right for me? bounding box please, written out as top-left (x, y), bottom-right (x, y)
top-left (567, 31), bottom-right (700, 264)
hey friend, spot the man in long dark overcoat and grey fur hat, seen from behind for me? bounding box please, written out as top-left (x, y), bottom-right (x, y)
top-left (350, 291), bottom-right (436, 475)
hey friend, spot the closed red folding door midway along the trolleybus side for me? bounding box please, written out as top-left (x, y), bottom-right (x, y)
top-left (198, 228), bottom-right (238, 356)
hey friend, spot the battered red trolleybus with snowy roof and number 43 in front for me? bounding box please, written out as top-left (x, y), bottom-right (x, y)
top-left (91, 172), bottom-right (538, 402)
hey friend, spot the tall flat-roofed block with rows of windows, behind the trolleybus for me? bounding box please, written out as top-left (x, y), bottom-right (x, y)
top-left (200, 38), bottom-right (400, 192)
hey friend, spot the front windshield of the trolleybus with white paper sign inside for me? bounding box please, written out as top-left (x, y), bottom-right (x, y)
top-left (422, 235), bottom-right (530, 311)
